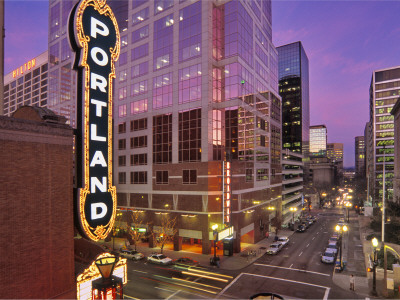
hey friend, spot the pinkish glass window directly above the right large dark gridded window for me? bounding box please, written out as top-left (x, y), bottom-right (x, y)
top-left (179, 64), bottom-right (201, 104)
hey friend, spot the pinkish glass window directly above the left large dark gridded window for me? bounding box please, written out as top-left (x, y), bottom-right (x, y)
top-left (153, 72), bottom-right (172, 109)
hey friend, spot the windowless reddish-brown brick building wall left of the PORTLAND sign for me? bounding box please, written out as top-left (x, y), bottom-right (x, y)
top-left (0, 107), bottom-right (76, 298)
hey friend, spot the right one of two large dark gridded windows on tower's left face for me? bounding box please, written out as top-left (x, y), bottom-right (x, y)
top-left (179, 108), bottom-right (201, 162)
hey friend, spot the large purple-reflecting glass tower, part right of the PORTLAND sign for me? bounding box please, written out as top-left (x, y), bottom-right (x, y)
top-left (114, 0), bottom-right (282, 253)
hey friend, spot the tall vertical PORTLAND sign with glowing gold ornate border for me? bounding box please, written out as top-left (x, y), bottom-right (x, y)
top-left (68, 0), bottom-right (120, 241)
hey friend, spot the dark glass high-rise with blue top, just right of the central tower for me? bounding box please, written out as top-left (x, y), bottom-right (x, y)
top-left (276, 42), bottom-right (310, 156)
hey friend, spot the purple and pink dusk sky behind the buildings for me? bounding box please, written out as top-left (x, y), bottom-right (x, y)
top-left (5, 0), bottom-right (400, 167)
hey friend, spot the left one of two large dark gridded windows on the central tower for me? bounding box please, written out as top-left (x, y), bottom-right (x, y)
top-left (153, 114), bottom-right (172, 164)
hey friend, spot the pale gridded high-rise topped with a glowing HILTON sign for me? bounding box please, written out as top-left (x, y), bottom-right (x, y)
top-left (3, 51), bottom-right (49, 116)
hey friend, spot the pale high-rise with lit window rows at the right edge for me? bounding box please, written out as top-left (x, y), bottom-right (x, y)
top-left (369, 66), bottom-right (400, 203)
